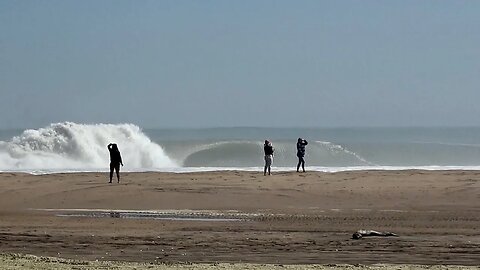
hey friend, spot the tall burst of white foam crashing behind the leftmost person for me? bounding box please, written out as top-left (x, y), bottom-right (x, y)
top-left (0, 122), bottom-right (177, 171)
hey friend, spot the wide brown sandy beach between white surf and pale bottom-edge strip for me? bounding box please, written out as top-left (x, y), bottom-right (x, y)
top-left (0, 171), bottom-right (480, 269)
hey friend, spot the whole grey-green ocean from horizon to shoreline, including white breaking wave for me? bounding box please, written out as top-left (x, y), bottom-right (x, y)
top-left (0, 122), bottom-right (480, 174)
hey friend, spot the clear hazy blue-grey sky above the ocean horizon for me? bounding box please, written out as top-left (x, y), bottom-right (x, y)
top-left (0, 0), bottom-right (480, 129)
